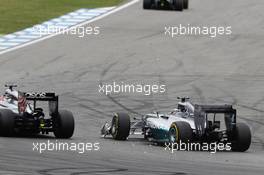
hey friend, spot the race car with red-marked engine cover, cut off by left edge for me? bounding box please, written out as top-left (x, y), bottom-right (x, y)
top-left (0, 85), bottom-right (74, 138)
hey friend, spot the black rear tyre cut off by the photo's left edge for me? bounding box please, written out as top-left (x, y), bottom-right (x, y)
top-left (0, 109), bottom-right (16, 136)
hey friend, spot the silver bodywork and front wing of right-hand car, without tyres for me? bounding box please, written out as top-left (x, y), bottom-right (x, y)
top-left (101, 100), bottom-right (196, 141)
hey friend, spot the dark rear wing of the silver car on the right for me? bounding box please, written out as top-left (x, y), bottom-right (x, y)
top-left (194, 105), bottom-right (236, 137)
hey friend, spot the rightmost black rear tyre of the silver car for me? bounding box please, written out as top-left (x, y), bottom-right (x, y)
top-left (232, 123), bottom-right (251, 152)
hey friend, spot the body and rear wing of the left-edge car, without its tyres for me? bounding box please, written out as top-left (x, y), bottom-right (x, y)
top-left (0, 85), bottom-right (59, 134)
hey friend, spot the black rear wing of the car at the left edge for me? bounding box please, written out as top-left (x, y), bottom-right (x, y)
top-left (23, 92), bottom-right (59, 116)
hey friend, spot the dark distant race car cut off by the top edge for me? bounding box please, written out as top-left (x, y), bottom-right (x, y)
top-left (143, 0), bottom-right (189, 11)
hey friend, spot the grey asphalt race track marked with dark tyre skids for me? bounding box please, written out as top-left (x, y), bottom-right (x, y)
top-left (0, 0), bottom-right (264, 175)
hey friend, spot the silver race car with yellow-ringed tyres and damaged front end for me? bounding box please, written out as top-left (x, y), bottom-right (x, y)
top-left (101, 97), bottom-right (251, 152)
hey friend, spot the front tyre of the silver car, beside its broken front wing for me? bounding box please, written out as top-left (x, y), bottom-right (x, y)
top-left (111, 113), bottom-right (130, 140)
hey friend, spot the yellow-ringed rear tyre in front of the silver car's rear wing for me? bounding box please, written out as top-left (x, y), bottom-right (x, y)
top-left (169, 121), bottom-right (193, 144)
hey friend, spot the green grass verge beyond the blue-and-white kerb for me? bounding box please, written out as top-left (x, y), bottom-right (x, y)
top-left (0, 0), bottom-right (123, 35)
